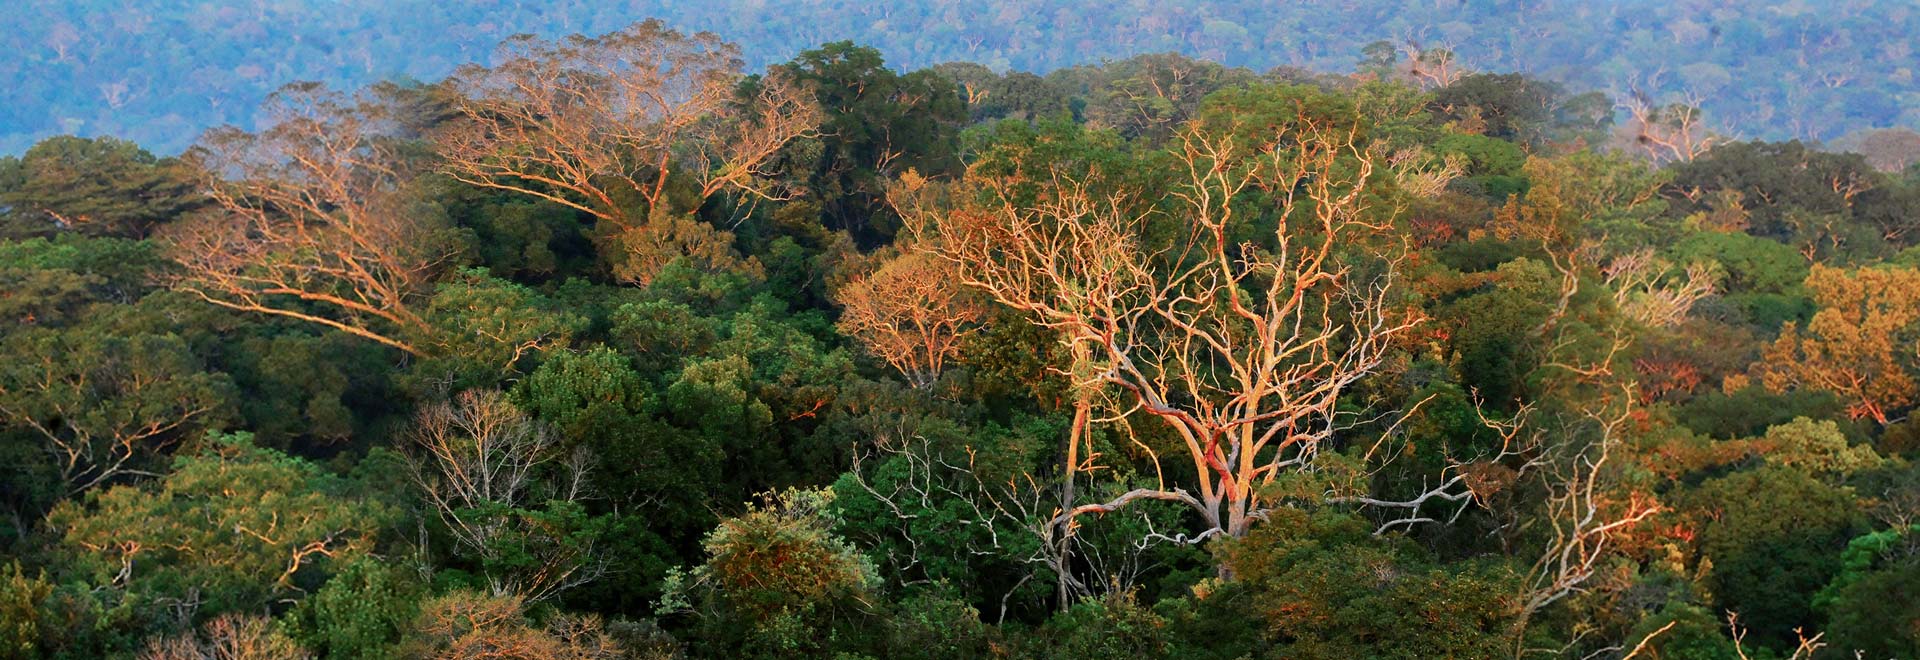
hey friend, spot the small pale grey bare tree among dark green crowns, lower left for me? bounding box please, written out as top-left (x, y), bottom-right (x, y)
top-left (409, 389), bottom-right (605, 602)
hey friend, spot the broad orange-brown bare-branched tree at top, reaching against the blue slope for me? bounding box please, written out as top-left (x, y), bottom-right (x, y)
top-left (438, 21), bottom-right (820, 232)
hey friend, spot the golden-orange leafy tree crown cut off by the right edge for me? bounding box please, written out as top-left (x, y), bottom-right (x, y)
top-left (1753, 265), bottom-right (1920, 426)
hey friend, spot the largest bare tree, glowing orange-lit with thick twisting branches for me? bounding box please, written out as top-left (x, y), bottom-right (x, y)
top-left (899, 88), bottom-right (1417, 539)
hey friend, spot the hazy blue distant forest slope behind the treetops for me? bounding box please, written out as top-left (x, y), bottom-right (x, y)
top-left (0, 0), bottom-right (1920, 153)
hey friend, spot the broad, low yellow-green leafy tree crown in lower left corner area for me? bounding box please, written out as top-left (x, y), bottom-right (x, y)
top-left (48, 434), bottom-right (386, 618)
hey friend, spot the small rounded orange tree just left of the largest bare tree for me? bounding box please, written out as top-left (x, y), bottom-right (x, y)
top-left (837, 251), bottom-right (987, 388)
